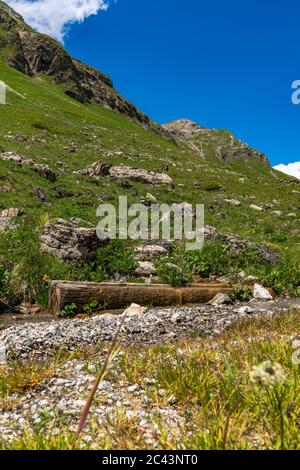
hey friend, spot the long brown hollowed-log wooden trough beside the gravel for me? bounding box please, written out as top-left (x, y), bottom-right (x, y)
top-left (49, 281), bottom-right (233, 314)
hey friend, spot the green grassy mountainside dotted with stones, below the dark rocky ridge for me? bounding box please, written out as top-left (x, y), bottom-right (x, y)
top-left (0, 62), bottom-right (300, 302)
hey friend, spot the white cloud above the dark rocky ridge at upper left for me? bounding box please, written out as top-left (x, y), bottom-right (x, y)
top-left (5, 0), bottom-right (108, 42)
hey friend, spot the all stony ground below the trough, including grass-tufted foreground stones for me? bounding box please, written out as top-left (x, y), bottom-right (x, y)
top-left (0, 300), bottom-right (299, 448)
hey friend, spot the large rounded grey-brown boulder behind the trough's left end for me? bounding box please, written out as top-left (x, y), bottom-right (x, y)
top-left (40, 219), bottom-right (107, 263)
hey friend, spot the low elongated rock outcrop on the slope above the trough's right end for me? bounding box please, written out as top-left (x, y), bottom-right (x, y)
top-left (204, 225), bottom-right (280, 264)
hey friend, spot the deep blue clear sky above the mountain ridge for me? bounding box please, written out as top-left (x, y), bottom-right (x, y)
top-left (8, 0), bottom-right (300, 174)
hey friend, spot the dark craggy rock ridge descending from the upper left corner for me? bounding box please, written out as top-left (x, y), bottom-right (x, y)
top-left (0, 1), bottom-right (168, 136)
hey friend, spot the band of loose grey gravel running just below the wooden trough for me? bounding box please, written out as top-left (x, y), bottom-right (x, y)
top-left (0, 300), bottom-right (299, 363)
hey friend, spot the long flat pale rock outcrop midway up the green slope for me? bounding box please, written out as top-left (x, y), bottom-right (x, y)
top-left (76, 162), bottom-right (174, 186)
